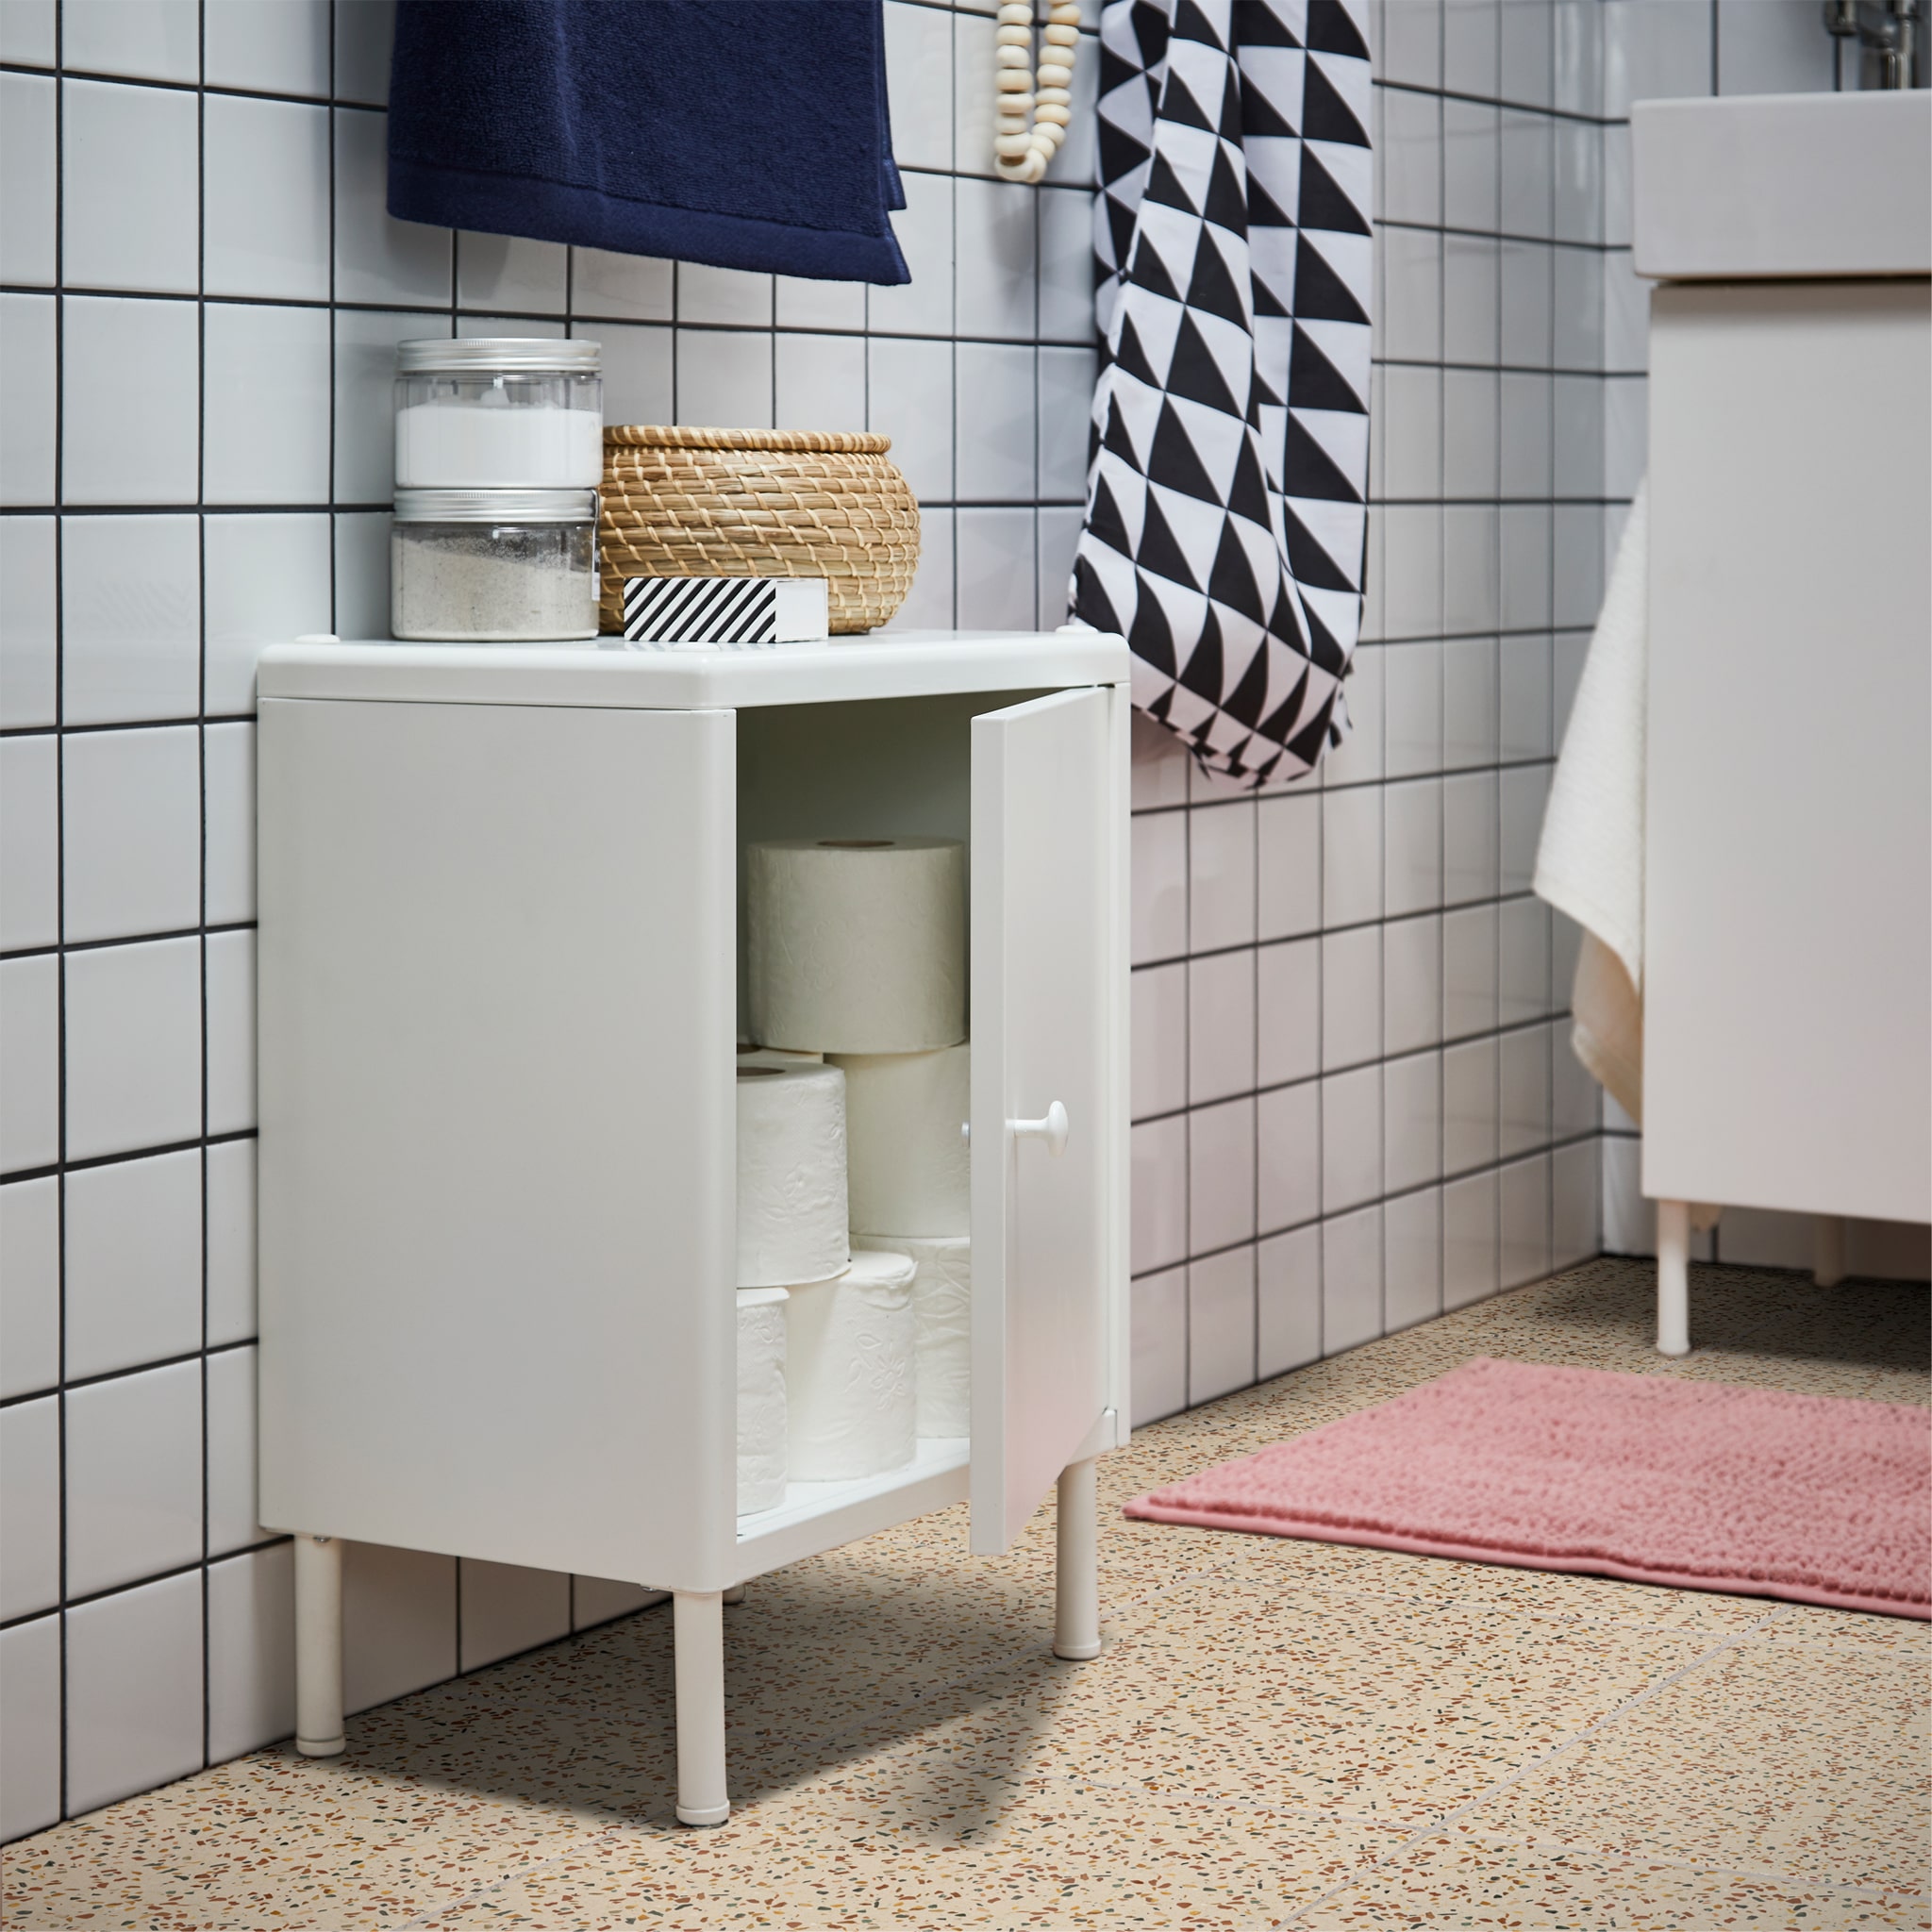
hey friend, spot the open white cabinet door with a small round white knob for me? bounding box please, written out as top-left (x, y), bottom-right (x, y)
top-left (972, 688), bottom-right (1124, 1554)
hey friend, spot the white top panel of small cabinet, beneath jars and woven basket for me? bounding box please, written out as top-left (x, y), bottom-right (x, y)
top-left (255, 630), bottom-right (1130, 711)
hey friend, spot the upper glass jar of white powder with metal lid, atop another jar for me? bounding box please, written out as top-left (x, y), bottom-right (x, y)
top-left (396, 336), bottom-right (603, 489)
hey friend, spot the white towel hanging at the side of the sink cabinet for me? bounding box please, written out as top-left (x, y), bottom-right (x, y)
top-left (1534, 483), bottom-right (1650, 1121)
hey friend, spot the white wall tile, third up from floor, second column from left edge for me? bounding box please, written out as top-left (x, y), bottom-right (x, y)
top-left (66, 1148), bottom-right (201, 1379)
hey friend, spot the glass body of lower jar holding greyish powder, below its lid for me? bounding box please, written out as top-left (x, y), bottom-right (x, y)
top-left (391, 524), bottom-right (597, 643)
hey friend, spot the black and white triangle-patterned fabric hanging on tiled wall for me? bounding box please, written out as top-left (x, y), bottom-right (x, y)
top-left (1071, 0), bottom-right (1372, 784)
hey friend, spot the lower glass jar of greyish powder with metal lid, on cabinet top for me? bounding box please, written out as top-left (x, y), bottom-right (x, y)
top-left (391, 489), bottom-right (597, 643)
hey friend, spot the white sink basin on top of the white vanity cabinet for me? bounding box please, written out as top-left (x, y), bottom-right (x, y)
top-left (1631, 89), bottom-right (1932, 280)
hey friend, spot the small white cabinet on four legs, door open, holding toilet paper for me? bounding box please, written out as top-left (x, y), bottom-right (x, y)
top-left (258, 632), bottom-right (1128, 1824)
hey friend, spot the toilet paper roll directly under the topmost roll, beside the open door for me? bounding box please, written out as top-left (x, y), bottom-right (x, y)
top-left (833, 1045), bottom-right (972, 1235)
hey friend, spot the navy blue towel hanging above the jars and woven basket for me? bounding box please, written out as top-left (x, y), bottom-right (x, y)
top-left (389, 0), bottom-right (912, 282)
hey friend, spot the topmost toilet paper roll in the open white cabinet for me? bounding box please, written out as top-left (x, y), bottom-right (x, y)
top-left (746, 839), bottom-right (966, 1053)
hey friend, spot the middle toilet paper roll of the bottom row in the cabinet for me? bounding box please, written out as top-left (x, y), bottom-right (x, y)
top-left (784, 1254), bottom-right (918, 1482)
